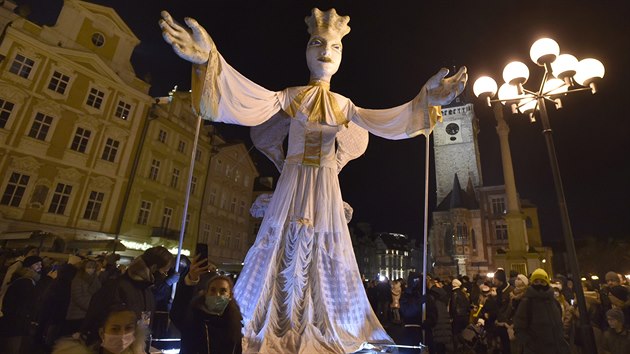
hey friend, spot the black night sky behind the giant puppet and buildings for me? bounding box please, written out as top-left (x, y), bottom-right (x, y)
top-left (16, 0), bottom-right (630, 248)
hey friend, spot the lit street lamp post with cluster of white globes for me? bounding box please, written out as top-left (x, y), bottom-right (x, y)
top-left (473, 38), bottom-right (604, 353)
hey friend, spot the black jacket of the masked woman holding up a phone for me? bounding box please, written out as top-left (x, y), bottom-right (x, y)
top-left (171, 281), bottom-right (242, 354)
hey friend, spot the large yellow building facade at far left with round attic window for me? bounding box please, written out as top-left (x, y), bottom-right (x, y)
top-left (0, 0), bottom-right (152, 250)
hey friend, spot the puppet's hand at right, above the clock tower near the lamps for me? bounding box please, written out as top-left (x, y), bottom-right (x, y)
top-left (426, 66), bottom-right (468, 106)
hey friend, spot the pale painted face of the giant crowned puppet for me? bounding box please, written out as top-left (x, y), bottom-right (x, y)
top-left (306, 32), bottom-right (343, 82)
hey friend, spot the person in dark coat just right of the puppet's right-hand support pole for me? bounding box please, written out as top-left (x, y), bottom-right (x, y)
top-left (422, 279), bottom-right (454, 354)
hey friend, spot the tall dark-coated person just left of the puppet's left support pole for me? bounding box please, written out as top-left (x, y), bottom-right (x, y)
top-left (81, 246), bottom-right (174, 342)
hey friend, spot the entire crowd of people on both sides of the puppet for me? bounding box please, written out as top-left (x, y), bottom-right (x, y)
top-left (0, 243), bottom-right (630, 354)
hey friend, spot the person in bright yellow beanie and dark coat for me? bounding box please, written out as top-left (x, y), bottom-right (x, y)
top-left (514, 268), bottom-right (570, 354)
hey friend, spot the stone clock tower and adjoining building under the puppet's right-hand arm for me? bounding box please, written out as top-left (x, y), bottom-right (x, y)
top-left (429, 96), bottom-right (551, 276)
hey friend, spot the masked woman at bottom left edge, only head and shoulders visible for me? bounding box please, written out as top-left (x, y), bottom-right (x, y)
top-left (52, 303), bottom-right (146, 354)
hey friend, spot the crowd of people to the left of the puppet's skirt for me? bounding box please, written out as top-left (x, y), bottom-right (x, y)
top-left (0, 246), bottom-right (241, 354)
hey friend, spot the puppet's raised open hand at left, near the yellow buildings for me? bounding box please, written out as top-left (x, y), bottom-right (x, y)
top-left (159, 11), bottom-right (213, 64)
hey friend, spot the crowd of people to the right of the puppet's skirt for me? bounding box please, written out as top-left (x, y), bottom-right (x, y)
top-left (366, 269), bottom-right (630, 354)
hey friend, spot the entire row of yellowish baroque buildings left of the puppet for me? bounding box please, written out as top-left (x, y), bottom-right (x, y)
top-left (0, 0), bottom-right (258, 263)
